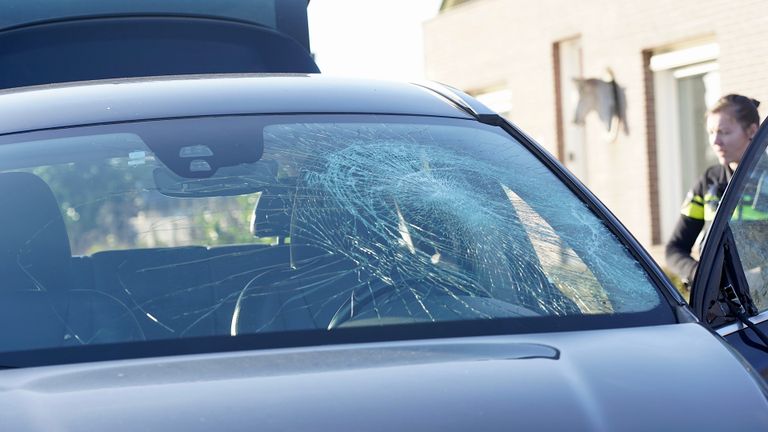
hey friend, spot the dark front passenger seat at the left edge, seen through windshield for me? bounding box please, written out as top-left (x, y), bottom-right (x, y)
top-left (0, 172), bottom-right (139, 351)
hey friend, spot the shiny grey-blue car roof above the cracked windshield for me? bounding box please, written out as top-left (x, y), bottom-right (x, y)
top-left (0, 74), bottom-right (476, 135)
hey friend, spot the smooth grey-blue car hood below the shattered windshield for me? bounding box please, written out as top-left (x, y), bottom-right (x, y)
top-left (0, 324), bottom-right (768, 432)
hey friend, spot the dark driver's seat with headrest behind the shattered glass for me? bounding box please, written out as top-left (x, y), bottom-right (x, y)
top-left (231, 180), bottom-right (359, 335)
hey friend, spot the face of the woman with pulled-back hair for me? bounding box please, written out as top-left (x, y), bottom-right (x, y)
top-left (707, 112), bottom-right (757, 165)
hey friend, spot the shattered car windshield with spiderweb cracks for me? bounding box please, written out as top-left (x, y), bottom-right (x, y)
top-left (0, 115), bottom-right (661, 358)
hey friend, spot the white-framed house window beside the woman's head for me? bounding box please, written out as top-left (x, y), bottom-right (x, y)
top-left (649, 43), bottom-right (720, 242)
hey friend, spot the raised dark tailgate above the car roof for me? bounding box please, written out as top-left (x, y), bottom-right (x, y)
top-left (0, 0), bottom-right (319, 88)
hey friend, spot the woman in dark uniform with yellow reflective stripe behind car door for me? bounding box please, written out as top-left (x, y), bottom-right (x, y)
top-left (666, 94), bottom-right (760, 287)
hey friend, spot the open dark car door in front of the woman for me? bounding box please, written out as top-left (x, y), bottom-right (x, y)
top-left (691, 118), bottom-right (768, 379)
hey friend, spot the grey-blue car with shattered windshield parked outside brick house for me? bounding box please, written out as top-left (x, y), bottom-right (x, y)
top-left (0, 74), bottom-right (768, 431)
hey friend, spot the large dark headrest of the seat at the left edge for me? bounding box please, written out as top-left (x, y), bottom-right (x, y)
top-left (0, 172), bottom-right (72, 291)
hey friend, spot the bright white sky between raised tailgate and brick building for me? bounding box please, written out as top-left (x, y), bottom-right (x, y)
top-left (307, 0), bottom-right (441, 80)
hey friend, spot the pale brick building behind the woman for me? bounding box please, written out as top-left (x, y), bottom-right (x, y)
top-left (424, 0), bottom-right (768, 263)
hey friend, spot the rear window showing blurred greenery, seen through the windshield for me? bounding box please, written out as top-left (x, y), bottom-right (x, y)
top-left (33, 159), bottom-right (264, 255)
